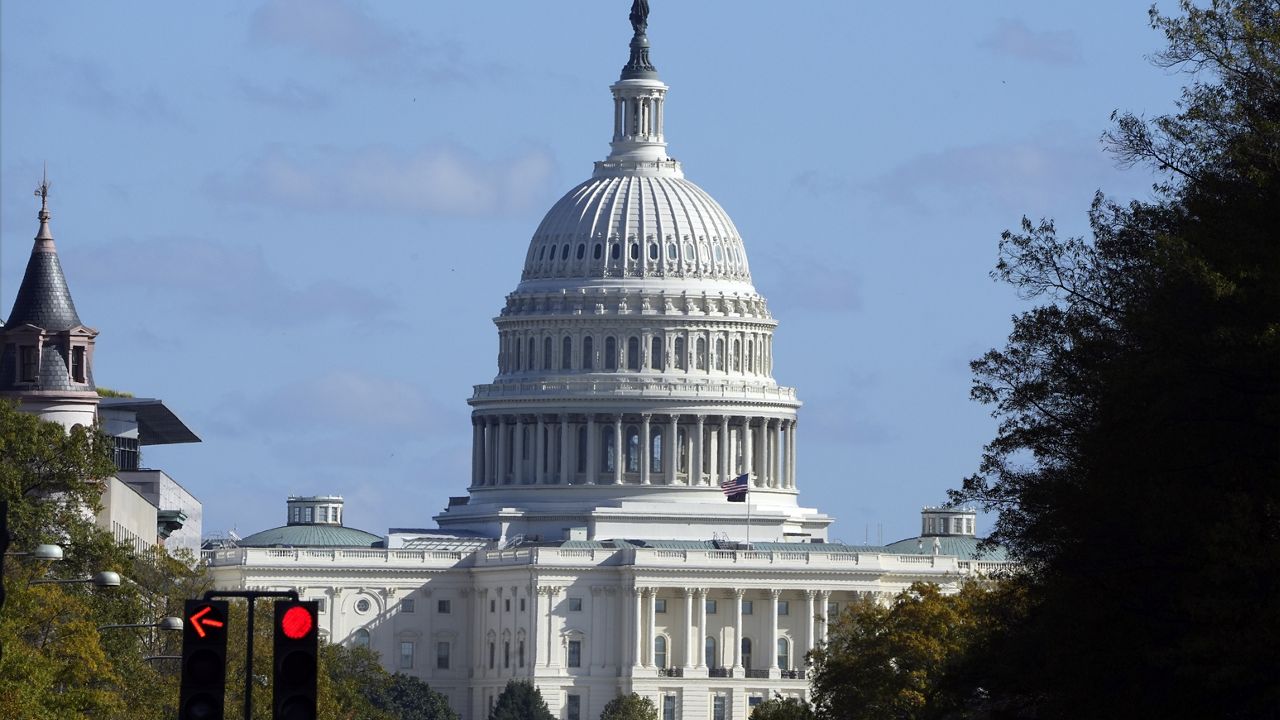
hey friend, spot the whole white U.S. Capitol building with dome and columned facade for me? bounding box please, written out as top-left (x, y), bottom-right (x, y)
top-left (206, 3), bottom-right (1002, 720)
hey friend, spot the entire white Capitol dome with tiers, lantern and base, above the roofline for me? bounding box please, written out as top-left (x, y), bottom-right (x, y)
top-left (435, 8), bottom-right (831, 541)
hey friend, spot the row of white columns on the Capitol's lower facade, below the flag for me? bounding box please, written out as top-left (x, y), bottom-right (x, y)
top-left (630, 587), bottom-right (831, 671)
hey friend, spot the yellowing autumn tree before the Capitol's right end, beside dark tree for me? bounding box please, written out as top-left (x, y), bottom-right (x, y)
top-left (808, 583), bottom-right (988, 720)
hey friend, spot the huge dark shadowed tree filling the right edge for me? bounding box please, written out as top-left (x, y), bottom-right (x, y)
top-left (952, 0), bottom-right (1280, 717)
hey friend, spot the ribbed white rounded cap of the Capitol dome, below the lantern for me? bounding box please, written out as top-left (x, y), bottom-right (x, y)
top-left (521, 173), bottom-right (751, 284)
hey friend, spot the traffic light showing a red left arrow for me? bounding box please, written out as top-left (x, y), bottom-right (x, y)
top-left (178, 600), bottom-right (227, 720)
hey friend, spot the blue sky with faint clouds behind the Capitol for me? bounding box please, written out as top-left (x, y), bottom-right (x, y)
top-left (0, 0), bottom-right (1185, 542)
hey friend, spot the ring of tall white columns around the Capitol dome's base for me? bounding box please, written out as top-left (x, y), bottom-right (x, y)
top-left (471, 413), bottom-right (796, 489)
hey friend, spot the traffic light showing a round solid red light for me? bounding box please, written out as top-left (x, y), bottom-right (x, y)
top-left (271, 600), bottom-right (320, 720)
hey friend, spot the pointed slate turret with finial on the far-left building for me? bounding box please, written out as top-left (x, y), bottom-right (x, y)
top-left (0, 178), bottom-right (99, 427)
